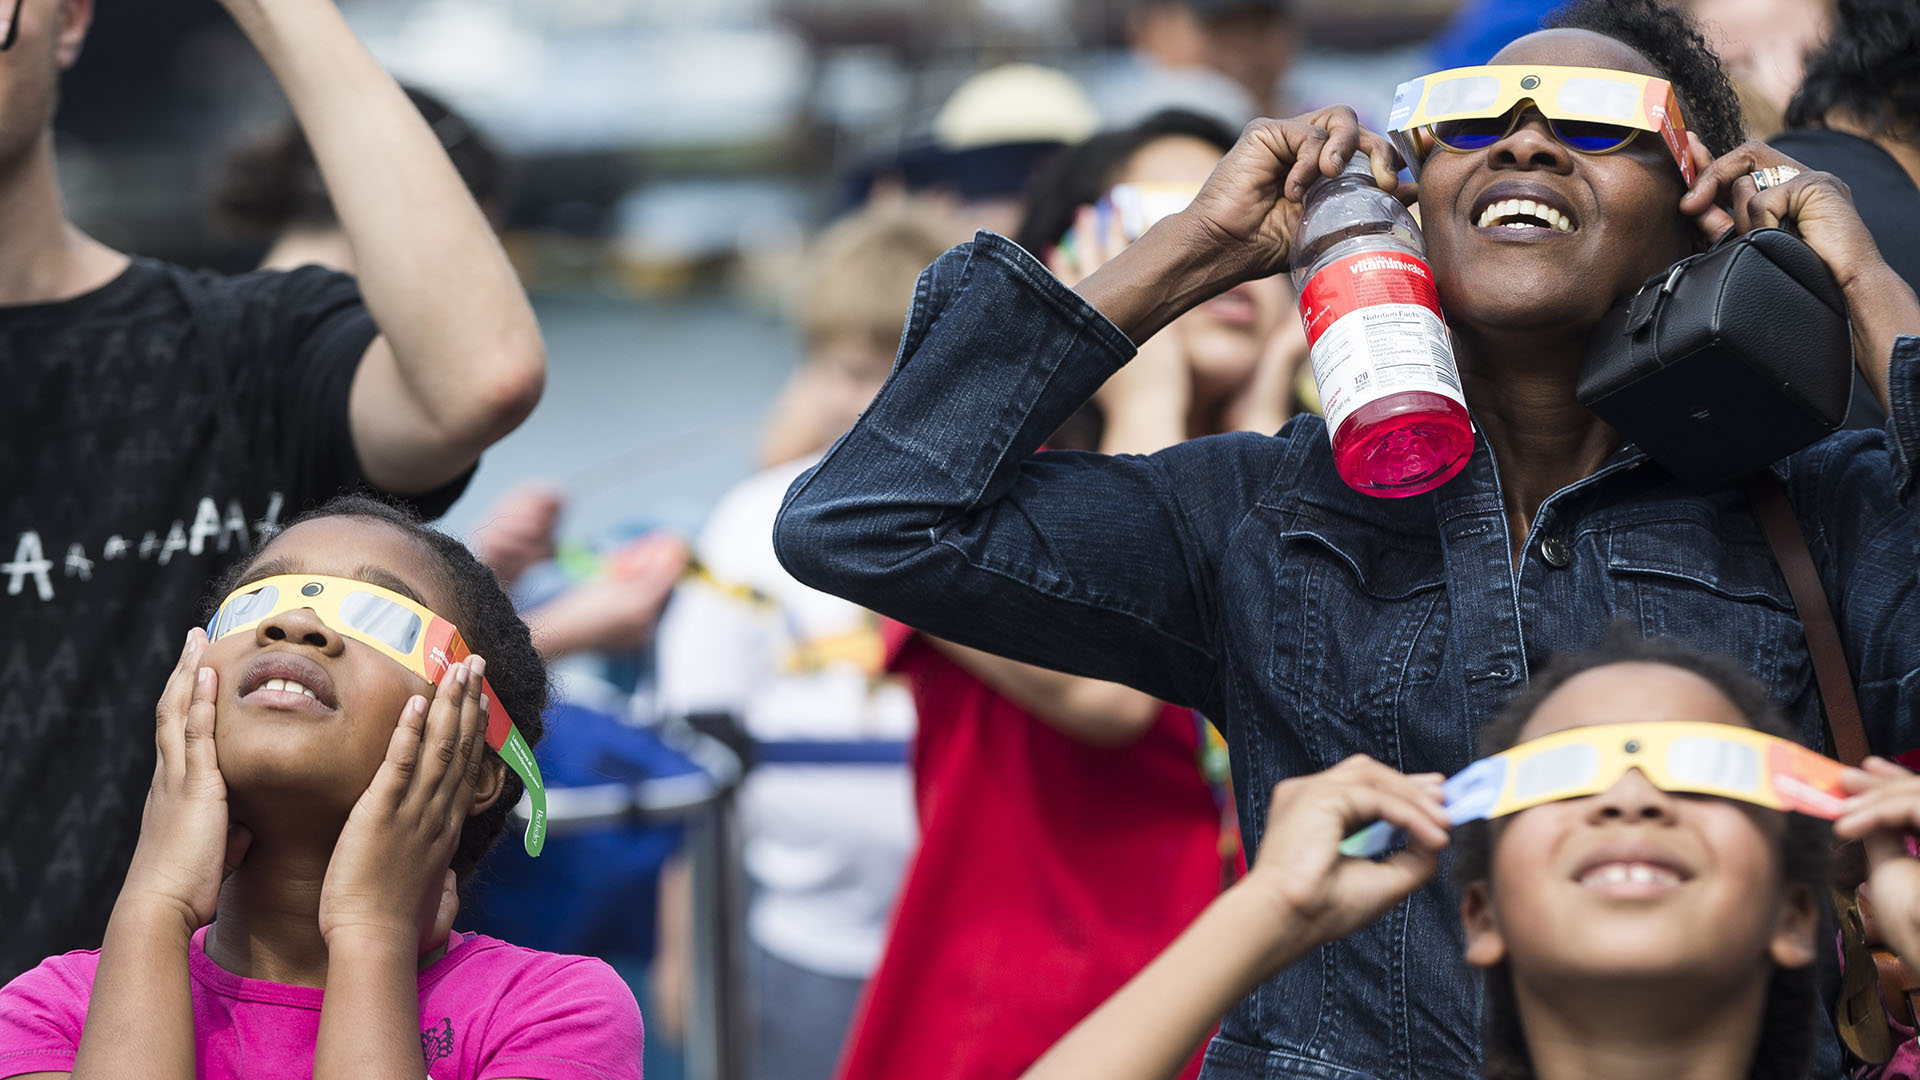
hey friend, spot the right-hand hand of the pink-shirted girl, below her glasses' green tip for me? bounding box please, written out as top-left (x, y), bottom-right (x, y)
top-left (321, 657), bottom-right (486, 957)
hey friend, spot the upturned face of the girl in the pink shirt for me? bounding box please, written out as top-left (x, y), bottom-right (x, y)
top-left (205, 517), bottom-right (453, 826)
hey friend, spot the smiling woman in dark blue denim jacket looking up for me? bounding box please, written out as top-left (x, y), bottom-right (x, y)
top-left (776, 0), bottom-right (1920, 1080)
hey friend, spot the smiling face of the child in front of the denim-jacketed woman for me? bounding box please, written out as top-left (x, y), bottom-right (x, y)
top-left (1461, 663), bottom-right (1816, 986)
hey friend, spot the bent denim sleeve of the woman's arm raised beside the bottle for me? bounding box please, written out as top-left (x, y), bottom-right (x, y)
top-left (774, 233), bottom-right (1286, 707)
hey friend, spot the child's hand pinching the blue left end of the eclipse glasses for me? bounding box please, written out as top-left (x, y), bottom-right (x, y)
top-left (1244, 755), bottom-right (1450, 957)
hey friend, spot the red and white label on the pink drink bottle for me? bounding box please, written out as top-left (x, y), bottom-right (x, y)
top-left (1300, 252), bottom-right (1467, 432)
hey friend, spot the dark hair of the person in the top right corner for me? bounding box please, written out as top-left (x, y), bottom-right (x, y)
top-left (1788, 0), bottom-right (1920, 140)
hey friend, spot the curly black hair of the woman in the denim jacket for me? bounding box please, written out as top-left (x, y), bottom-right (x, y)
top-left (1542, 0), bottom-right (1747, 158)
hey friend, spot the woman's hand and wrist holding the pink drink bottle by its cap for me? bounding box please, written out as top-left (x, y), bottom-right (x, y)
top-left (1077, 106), bottom-right (1413, 342)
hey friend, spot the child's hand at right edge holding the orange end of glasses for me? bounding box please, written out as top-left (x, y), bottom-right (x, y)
top-left (1834, 757), bottom-right (1920, 963)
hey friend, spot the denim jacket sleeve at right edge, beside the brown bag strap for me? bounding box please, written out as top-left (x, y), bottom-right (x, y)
top-left (1788, 336), bottom-right (1920, 753)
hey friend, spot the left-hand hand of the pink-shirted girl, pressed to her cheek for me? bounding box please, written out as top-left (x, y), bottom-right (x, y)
top-left (119, 626), bottom-right (252, 932)
